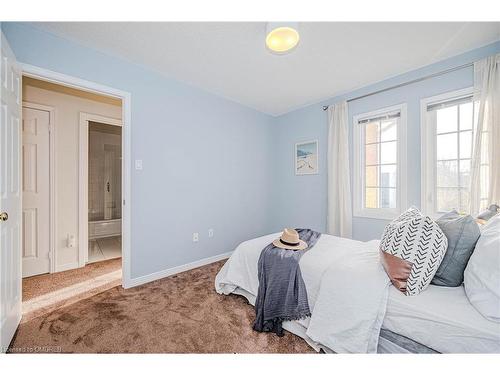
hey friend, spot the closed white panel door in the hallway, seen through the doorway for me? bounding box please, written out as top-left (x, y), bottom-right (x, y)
top-left (22, 107), bottom-right (50, 277)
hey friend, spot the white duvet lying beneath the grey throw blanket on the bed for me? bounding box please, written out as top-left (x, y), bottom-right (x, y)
top-left (215, 233), bottom-right (390, 353)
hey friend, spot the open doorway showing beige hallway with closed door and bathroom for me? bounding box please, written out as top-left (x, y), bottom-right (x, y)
top-left (21, 76), bottom-right (127, 321)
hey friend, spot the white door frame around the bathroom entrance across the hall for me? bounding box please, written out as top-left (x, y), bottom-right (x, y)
top-left (78, 112), bottom-right (124, 267)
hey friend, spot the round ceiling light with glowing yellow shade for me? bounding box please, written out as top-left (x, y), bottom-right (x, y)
top-left (266, 22), bottom-right (300, 55)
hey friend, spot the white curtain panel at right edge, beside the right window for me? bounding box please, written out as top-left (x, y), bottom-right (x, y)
top-left (470, 54), bottom-right (500, 214)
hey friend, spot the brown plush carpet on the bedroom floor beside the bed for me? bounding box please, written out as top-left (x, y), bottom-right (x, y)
top-left (10, 262), bottom-right (314, 353)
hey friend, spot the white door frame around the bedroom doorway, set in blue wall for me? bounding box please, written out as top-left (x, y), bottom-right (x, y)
top-left (19, 63), bottom-right (132, 288)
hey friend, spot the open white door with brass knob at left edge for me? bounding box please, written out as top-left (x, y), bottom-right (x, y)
top-left (0, 33), bottom-right (22, 352)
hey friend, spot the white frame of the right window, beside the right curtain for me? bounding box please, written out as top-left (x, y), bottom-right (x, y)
top-left (420, 87), bottom-right (475, 219)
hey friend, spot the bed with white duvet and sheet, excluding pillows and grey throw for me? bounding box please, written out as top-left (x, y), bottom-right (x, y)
top-left (215, 233), bottom-right (500, 353)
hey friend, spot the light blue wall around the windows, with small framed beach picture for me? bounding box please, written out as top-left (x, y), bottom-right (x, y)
top-left (271, 42), bottom-right (500, 240)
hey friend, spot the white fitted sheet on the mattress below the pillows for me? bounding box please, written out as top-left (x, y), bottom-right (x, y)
top-left (382, 285), bottom-right (500, 353)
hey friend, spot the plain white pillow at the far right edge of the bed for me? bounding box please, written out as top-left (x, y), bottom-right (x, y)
top-left (464, 215), bottom-right (500, 323)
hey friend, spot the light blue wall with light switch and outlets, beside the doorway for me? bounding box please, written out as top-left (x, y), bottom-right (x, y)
top-left (2, 23), bottom-right (272, 277)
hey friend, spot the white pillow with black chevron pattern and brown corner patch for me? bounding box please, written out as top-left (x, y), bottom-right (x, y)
top-left (380, 207), bottom-right (448, 296)
